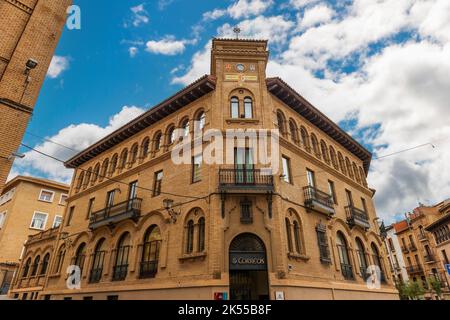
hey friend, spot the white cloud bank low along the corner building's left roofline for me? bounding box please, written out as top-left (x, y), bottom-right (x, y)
top-left (9, 106), bottom-right (144, 183)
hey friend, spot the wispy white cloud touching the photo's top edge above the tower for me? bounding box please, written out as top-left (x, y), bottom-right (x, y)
top-left (203, 0), bottom-right (273, 20)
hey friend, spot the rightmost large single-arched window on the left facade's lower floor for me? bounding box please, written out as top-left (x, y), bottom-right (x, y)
top-left (139, 225), bottom-right (161, 278)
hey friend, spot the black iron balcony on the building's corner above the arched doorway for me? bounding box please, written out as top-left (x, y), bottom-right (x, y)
top-left (219, 169), bottom-right (274, 193)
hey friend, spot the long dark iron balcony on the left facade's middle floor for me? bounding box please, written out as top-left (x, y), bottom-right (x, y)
top-left (89, 198), bottom-right (142, 230)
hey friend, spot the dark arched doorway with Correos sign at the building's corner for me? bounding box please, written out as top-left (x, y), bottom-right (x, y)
top-left (229, 233), bottom-right (269, 300)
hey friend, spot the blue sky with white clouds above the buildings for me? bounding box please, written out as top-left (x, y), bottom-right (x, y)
top-left (9, 0), bottom-right (450, 222)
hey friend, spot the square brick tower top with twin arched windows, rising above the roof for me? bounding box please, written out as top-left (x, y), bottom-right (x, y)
top-left (211, 39), bottom-right (272, 129)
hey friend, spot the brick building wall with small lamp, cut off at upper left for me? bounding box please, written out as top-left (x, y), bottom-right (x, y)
top-left (0, 0), bottom-right (72, 192)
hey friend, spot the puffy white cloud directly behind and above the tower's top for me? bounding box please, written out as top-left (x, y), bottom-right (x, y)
top-left (217, 16), bottom-right (294, 44)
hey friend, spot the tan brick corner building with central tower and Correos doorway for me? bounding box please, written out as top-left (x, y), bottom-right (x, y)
top-left (11, 39), bottom-right (397, 300)
